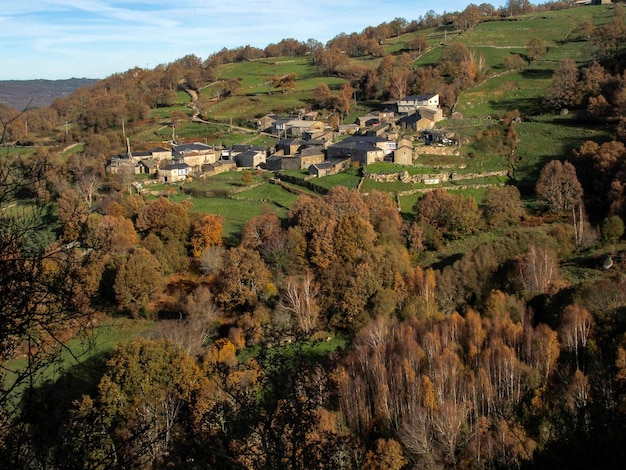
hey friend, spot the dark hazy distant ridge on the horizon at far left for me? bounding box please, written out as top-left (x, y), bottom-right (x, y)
top-left (0, 78), bottom-right (98, 110)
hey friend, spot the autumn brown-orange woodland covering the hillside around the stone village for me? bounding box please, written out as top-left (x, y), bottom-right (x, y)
top-left (0, 0), bottom-right (626, 470)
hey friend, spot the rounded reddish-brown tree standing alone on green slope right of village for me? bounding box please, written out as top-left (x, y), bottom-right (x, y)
top-left (535, 160), bottom-right (583, 213)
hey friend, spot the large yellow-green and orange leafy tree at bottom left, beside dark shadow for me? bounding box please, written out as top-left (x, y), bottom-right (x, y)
top-left (71, 339), bottom-right (205, 468)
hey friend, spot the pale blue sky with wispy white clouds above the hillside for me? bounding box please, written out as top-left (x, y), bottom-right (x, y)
top-left (0, 0), bottom-right (505, 80)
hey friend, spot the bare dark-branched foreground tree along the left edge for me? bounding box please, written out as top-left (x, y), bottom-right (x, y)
top-left (0, 154), bottom-right (94, 462)
